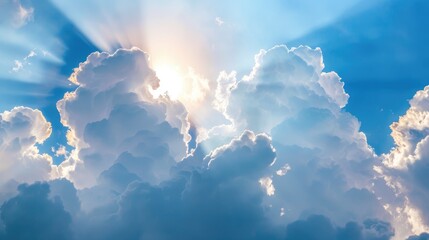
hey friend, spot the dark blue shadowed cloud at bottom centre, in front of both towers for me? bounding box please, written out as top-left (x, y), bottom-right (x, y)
top-left (63, 131), bottom-right (282, 239)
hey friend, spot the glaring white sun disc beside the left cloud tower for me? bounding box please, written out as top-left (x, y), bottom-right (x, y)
top-left (154, 64), bottom-right (184, 100)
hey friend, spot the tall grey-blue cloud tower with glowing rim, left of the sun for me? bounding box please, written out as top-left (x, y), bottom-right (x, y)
top-left (57, 48), bottom-right (189, 187)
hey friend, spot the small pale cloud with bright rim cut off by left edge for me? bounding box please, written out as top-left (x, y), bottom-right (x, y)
top-left (0, 107), bottom-right (55, 188)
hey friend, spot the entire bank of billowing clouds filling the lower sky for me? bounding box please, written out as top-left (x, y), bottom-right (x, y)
top-left (0, 46), bottom-right (429, 240)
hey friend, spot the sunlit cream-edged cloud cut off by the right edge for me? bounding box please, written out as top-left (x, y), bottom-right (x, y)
top-left (378, 86), bottom-right (429, 234)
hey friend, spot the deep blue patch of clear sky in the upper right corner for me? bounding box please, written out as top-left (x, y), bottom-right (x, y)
top-left (290, 0), bottom-right (429, 153)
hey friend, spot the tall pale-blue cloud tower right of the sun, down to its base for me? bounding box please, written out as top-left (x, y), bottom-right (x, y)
top-left (206, 46), bottom-right (390, 231)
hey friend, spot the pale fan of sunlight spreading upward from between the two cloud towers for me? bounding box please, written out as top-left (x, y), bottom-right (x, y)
top-left (47, 0), bottom-right (359, 133)
